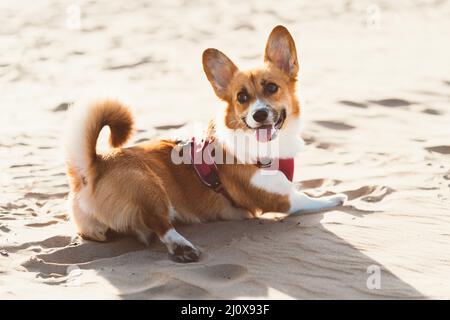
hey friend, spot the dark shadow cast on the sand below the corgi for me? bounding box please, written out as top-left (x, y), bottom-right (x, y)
top-left (19, 187), bottom-right (423, 299)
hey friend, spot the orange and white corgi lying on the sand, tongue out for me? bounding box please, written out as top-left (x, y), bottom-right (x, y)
top-left (66, 26), bottom-right (346, 262)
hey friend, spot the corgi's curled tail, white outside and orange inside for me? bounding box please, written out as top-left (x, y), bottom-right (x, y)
top-left (66, 99), bottom-right (134, 177)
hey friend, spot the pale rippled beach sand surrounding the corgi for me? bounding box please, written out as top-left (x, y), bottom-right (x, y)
top-left (0, 0), bottom-right (450, 299)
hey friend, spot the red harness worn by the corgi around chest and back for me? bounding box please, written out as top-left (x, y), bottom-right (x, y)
top-left (190, 137), bottom-right (294, 207)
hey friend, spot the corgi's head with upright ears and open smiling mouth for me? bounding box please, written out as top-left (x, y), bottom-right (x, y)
top-left (203, 26), bottom-right (300, 147)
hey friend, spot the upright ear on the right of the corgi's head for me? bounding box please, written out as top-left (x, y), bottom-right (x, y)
top-left (264, 26), bottom-right (298, 79)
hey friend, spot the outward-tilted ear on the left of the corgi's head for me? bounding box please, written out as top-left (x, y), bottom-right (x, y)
top-left (203, 49), bottom-right (238, 99)
